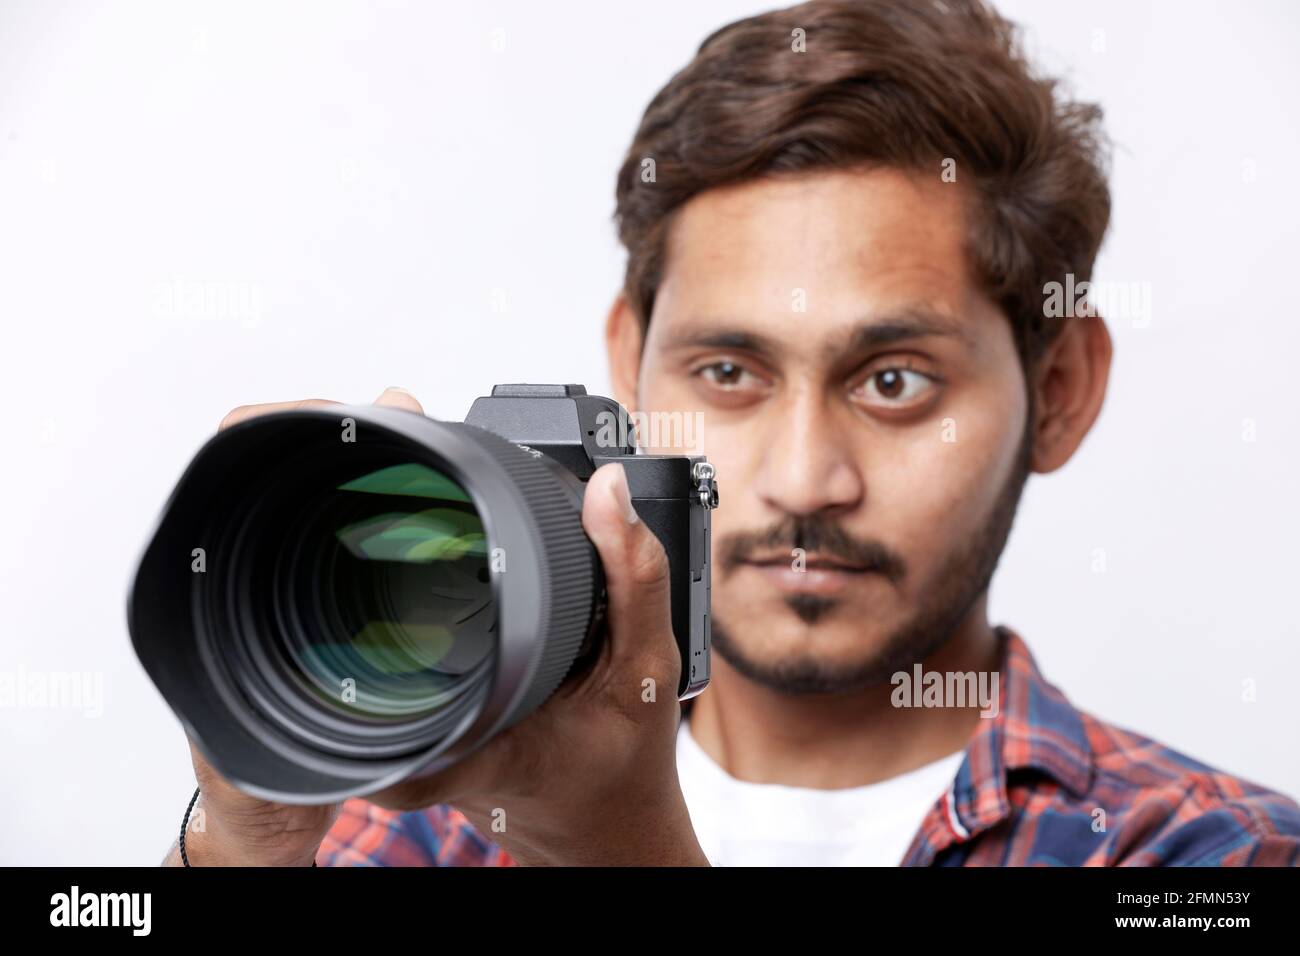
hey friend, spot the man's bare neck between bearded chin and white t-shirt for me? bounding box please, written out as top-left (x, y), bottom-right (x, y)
top-left (689, 597), bottom-right (998, 790)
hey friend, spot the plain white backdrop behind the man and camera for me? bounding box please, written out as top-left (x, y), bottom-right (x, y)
top-left (0, 0), bottom-right (1300, 864)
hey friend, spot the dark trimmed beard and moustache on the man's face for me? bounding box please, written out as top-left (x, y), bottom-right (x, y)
top-left (712, 406), bottom-right (1034, 695)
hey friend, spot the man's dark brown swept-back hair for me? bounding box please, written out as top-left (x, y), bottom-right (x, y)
top-left (615, 0), bottom-right (1110, 369)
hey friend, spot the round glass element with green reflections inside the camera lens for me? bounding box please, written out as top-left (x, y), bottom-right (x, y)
top-left (276, 462), bottom-right (497, 721)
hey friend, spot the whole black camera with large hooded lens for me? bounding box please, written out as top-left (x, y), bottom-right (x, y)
top-left (127, 385), bottom-right (718, 804)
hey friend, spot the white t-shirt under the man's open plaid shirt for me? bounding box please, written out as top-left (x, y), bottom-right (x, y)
top-left (677, 721), bottom-right (965, 866)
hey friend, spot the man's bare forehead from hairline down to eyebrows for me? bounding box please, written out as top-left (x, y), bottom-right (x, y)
top-left (651, 169), bottom-right (987, 361)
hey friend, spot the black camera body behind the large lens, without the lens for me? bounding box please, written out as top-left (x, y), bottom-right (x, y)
top-left (465, 385), bottom-right (718, 700)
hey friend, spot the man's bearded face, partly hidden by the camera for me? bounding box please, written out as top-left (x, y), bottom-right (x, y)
top-left (636, 169), bottom-right (1028, 693)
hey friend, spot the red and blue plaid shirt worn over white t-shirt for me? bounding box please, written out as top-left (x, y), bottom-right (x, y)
top-left (317, 627), bottom-right (1300, 866)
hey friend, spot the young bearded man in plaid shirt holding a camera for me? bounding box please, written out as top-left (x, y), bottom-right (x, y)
top-left (169, 0), bottom-right (1300, 865)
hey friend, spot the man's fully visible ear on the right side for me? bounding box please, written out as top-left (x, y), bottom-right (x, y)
top-left (1031, 316), bottom-right (1113, 475)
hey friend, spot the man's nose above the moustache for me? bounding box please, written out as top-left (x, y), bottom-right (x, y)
top-left (755, 395), bottom-right (866, 515)
